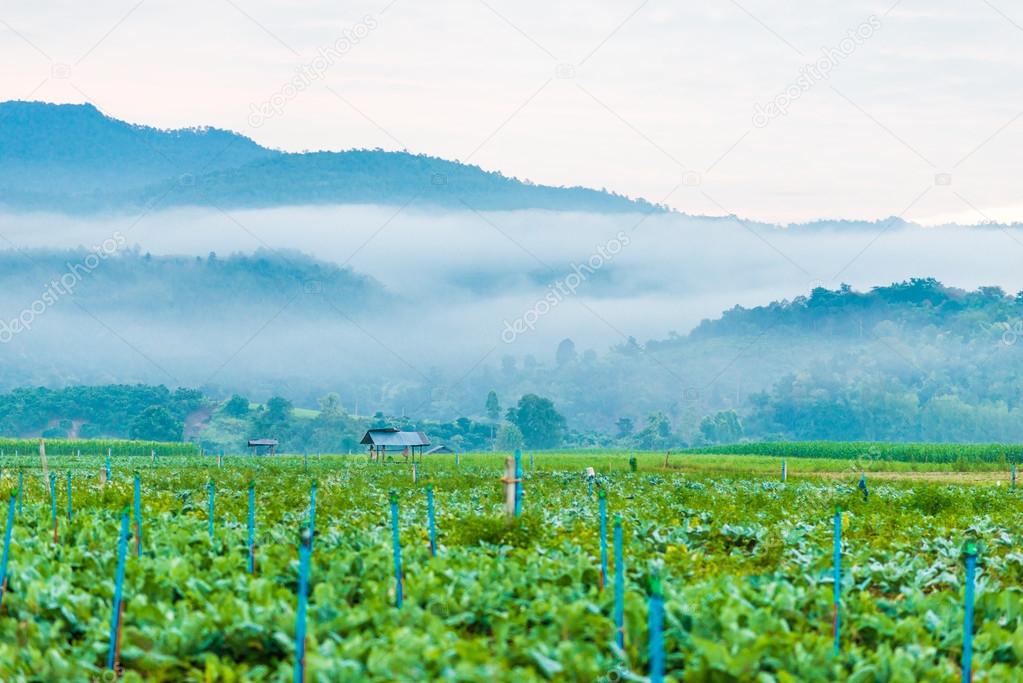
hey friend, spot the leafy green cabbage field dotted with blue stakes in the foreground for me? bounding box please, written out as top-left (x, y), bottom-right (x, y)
top-left (0, 452), bottom-right (1023, 683)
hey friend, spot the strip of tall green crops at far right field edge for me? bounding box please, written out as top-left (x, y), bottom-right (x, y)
top-left (683, 441), bottom-right (1023, 464)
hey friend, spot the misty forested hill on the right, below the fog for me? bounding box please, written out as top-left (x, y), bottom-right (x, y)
top-left (472, 278), bottom-right (1023, 448)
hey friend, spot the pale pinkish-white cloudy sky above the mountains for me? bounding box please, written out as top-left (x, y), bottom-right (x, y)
top-left (0, 0), bottom-right (1023, 223)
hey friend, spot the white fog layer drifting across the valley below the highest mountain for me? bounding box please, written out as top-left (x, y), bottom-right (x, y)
top-left (0, 206), bottom-right (1023, 412)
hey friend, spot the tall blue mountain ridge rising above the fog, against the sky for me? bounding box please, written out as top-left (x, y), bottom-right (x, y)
top-left (0, 101), bottom-right (663, 213)
